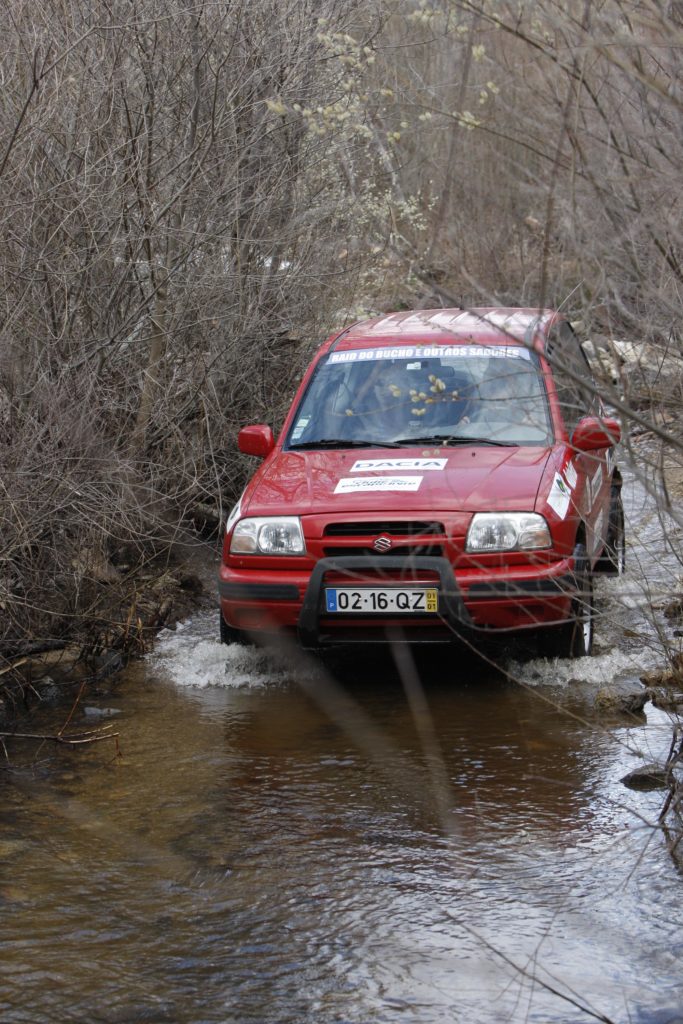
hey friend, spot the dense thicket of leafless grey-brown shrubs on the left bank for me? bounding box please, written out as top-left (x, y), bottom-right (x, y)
top-left (0, 0), bottom-right (387, 645)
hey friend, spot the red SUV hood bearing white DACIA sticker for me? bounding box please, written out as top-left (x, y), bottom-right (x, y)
top-left (242, 445), bottom-right (551, 515)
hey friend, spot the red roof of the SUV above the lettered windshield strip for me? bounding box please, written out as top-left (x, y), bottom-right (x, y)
top-left (331, 306), bottom-right (558, 350)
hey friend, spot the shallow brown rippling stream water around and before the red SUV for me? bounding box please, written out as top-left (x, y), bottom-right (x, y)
top-left (0, 468), bottom-right (683, 1024)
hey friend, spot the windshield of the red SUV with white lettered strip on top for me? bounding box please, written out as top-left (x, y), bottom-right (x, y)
top-left (287, 345), bottom-right (552, 449)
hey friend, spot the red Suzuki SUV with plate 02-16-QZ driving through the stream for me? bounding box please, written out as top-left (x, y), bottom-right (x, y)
top-left (219, 308), bottom-right (625, 656)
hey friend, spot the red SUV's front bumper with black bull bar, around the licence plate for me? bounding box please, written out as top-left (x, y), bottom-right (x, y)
top-left (219, 555), bottom-right (577, 648)
